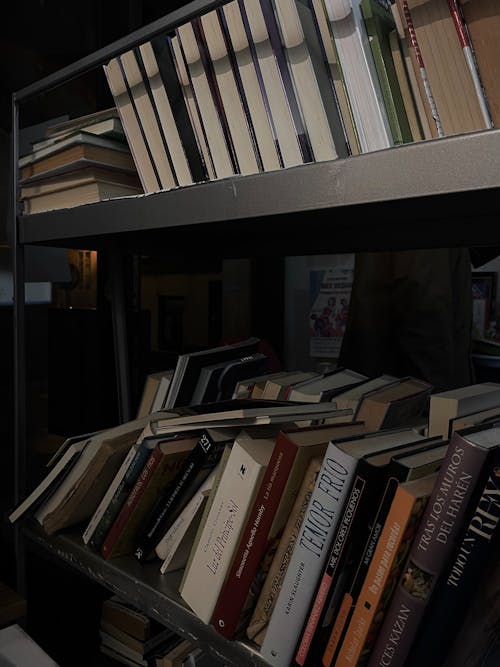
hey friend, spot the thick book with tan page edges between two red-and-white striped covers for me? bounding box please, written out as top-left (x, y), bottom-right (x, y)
top-left (396, 0), bottom-right (488, 136)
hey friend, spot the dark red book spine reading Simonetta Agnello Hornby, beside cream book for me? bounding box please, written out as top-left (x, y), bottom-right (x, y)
top-left (211, 433), bottom-right (297, 639)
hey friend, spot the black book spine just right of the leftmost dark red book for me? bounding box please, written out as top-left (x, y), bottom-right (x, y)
top-left (133, 431), bottom-right (227, 561)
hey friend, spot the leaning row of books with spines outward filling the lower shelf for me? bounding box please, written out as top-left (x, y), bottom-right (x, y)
top-left (9, 341), bottom-right (500, 667)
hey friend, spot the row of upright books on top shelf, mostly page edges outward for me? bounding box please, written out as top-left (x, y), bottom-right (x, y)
top-left (99, 0), bottom-right (500, 192)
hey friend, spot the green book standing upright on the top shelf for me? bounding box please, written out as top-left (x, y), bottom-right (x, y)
top-left (360, 0), bottom-right (414, 146)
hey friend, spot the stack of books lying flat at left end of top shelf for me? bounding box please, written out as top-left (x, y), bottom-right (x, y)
top-left (19, 107), bottom-right (143, 214)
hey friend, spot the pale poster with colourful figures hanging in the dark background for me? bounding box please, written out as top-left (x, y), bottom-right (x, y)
top-left (309, 266), bottom-right (353, 358)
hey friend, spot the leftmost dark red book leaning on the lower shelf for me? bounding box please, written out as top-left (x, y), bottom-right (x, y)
top-left (100, 434), bottom-right (198, 560)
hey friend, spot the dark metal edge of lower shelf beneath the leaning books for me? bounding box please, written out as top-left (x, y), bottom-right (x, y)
top-left (23, 525), bottom-right (268, 667)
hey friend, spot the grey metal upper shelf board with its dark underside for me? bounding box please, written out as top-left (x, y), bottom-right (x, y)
top-left (19, 130), bottom-right (500, 256)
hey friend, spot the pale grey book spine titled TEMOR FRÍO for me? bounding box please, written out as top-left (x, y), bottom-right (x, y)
top-left (260, 441), bottom-right (357, 667)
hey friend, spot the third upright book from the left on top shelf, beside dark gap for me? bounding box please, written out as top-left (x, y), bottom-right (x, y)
top-left (138, 41), bottom-right (194, 186)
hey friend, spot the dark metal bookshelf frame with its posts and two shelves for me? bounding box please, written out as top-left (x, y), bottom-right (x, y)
top-left (11, 0), bottom-right (500, 667)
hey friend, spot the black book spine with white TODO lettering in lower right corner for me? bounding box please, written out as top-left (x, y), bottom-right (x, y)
top-left (408, 451), bottom-right (500, 667)
